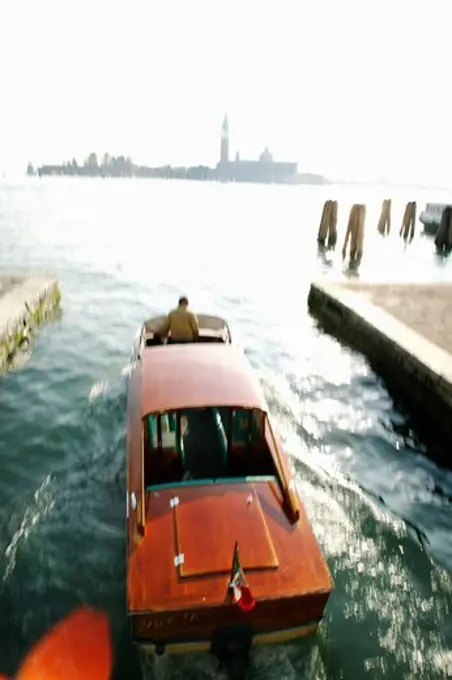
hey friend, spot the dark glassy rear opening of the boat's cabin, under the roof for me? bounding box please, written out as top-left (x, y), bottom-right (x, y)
top-left (143, 407), bottom-right (278, 488)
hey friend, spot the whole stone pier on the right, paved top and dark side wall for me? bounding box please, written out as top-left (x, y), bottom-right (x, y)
top-left (308, 281), bottom-right (452, 448)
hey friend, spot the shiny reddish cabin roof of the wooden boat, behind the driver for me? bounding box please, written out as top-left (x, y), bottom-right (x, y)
top-left (141, 342), bottom-right (267, 418)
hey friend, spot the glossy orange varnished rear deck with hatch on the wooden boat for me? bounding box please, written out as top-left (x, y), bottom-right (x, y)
top-left (127, 482), bottom-right (333, 614)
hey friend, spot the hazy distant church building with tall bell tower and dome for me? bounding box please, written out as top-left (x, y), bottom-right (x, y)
top-left (216, 116), bottom-right (298, 184)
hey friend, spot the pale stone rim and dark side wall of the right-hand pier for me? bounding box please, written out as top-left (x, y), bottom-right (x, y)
top-left (308, 282), bottom-right (452, 446)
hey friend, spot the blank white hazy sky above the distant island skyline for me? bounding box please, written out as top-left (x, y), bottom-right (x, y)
top-left (0, 0), bottom-right (452, 184)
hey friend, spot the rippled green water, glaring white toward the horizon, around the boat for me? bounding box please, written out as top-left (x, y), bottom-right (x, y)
top-left (0, 178), bottom-right (452, 680)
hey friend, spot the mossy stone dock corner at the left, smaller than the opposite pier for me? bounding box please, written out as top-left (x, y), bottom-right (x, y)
top-left (0, 273), bottom-right (61, 372)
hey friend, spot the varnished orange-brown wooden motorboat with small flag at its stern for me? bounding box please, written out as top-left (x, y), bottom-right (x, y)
top-left (127, 315), bottom-right (333, 656)
